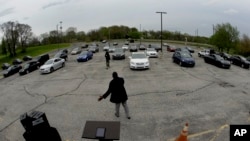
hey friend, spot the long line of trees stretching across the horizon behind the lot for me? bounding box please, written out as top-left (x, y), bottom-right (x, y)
top-left (0, 21), bottom-right (250, 57)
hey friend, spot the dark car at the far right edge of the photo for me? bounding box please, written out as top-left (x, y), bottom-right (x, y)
top-left (230, 55), bottom-right (250, 69)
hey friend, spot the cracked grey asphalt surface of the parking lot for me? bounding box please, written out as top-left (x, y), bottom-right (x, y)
top-left (0, 43), bottom-right (250, 141)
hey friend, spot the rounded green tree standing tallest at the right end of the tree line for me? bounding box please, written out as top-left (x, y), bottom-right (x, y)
top-left (211, 23), bottom-right (239, 52)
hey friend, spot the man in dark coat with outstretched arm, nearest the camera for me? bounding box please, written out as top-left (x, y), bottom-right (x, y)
top-left (98, 72), bottom-right (130, 119)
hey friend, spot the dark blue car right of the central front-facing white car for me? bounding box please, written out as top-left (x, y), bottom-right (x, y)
top-left (172, 51), bottom-right (195, 67)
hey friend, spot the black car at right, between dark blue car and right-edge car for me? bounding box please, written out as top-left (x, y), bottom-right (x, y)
top-left (204, 54), bottom-right (231, 69)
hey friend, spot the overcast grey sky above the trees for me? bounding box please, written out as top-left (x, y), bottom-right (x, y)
top-left (0, 0), bottom-right (250, 37)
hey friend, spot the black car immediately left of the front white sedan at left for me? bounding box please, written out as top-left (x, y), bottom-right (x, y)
top-left (19, 60), bottom-right (40, 75)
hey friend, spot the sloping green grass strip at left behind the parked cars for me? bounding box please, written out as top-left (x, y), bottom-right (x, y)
top-left (0, 43), bottom-right (70, 65)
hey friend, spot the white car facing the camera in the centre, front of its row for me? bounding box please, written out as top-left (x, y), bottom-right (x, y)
top-left (129, 52), bottom-right (150, 69)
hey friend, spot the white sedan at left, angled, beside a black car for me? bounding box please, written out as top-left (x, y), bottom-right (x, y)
top-left (39, 58), bottom-right (65, 74)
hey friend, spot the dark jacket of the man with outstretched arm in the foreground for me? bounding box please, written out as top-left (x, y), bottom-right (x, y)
top-left (103, 77), bottom-right (128, 103)
